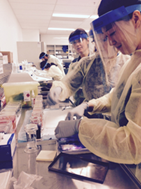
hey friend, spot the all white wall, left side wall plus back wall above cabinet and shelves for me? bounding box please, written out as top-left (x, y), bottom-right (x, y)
top-left (0, 0), bottom-right (69, 62)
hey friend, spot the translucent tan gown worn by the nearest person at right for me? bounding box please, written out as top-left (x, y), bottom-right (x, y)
top-left (79, 50), bottom-right (141, 164)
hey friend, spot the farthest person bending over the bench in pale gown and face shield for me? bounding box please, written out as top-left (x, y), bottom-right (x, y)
top-left (39, 52), bottom-right (65, 75)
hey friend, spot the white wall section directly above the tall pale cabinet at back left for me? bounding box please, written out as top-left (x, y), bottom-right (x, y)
top-left (22, 29), bottom-right (40, 41)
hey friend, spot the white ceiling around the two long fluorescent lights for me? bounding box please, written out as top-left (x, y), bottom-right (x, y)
top-left (8, 0), bottom-right (100, 35)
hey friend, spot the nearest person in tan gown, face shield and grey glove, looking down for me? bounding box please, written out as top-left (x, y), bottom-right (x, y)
top-left (55, 0), bottom-right (141, 164)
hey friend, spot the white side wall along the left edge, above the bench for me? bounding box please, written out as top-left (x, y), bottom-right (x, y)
top-left (0, 0), bottom-right (22, 62)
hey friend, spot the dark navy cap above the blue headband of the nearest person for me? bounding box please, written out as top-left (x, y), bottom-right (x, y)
top-left (98, 0), bottom-right (141, 16)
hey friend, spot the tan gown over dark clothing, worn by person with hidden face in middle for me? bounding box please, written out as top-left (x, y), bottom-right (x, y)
top-left (52, 53), bottom-right (130, 101)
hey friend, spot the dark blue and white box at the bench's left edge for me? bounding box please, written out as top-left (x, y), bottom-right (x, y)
top-left (0, 133), bottom-right (16, 169)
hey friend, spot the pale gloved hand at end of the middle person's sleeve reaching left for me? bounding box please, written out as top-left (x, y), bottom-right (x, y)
top-left (47, 87), bottom-right (62, 106)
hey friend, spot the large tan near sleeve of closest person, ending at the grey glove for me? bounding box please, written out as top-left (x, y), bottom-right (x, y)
top-left (79, 71), bottom-right (141, 164)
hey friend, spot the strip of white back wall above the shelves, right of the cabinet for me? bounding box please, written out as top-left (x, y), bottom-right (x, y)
top-left (41, 34), bottom-right (69, 45)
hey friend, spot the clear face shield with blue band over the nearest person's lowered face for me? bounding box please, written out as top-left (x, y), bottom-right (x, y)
top-left (91, 5), bottom-right (141, 60)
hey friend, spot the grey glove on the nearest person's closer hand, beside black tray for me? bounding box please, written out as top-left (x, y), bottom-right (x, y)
top-left (55, 119), bottom-right (81, 138)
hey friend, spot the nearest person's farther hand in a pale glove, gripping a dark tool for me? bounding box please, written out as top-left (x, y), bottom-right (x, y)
top-left (65, 102), bottom-right (88, 120)
